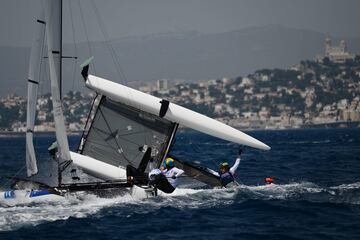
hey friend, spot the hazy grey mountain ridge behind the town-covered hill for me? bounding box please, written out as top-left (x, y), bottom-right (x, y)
top-left (0, 25), bottom-right (360, 95)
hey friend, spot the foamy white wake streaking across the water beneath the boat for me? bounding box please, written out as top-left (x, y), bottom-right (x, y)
top-left (0, 182), bottom-right (360, 231)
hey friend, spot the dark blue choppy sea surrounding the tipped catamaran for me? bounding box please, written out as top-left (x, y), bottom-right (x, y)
top-left (0, 129), bottom-right (360, 240)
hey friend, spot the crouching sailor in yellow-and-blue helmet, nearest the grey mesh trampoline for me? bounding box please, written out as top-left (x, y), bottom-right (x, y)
top-left (149, 157), bottom-right (184, 193)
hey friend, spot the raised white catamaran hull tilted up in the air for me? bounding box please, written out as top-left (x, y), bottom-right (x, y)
top-left (86, 75), bottom-right (270, 150)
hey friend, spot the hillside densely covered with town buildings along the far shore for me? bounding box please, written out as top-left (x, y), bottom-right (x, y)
top-left (0, 55), bottom-right (360, 131)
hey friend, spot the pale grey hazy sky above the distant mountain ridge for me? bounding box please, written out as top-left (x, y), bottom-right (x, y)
top-left (0, 0), bottom-right (360, 46)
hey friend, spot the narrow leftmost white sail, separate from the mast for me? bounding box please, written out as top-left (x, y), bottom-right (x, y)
top-left (26, 12), bottom-right (45, 177)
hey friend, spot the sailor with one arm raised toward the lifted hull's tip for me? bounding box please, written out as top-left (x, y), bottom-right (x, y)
top-left (208, 149), bottom-right (242, 187)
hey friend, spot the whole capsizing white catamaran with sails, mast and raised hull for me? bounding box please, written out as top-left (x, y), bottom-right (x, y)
top-left (0, 0), bottom-right (270, 205)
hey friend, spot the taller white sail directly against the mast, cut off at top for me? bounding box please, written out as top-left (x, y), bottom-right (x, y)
top-left (43, 0), bottom-right (70, 160)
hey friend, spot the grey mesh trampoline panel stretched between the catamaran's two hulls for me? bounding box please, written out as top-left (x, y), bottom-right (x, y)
top-left (82, 97), bottom-right (174, 171)
